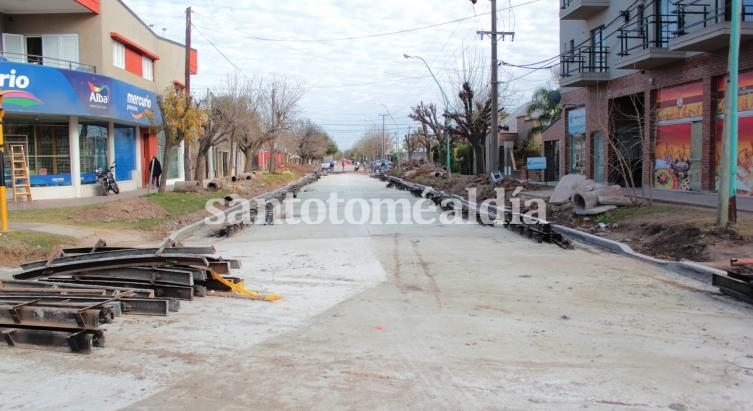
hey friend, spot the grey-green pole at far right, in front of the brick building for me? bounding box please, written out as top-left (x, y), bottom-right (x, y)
top-left (719, 0), bottom-right (742, 228)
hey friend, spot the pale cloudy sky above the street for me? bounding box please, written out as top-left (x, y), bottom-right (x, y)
top-left (123, 0), bottom-right (559, 150)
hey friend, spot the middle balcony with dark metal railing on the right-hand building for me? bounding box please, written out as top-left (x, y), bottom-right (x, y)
top-left (614, 15), bottom-right (685, 69)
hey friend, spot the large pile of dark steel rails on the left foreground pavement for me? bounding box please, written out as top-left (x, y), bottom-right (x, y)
top-left (0, 245), bottom-right (242, 353)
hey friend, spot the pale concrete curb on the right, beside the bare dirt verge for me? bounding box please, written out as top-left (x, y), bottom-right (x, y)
top-left (552, 224), bottom-right (727, 285)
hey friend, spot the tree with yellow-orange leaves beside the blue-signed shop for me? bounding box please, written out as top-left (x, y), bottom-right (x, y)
top-left (157, 87), bottom-right (207, 193)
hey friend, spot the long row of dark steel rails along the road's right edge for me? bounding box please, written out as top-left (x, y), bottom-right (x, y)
top-left (379, 175), bottom-right (570, 248)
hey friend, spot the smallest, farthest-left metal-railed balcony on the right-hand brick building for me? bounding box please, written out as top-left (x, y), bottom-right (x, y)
top-left (560, 46), bottom-right (609, 87)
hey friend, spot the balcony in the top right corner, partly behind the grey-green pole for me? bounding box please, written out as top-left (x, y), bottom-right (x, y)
top-left (669, 1), bottom-right (753, 52)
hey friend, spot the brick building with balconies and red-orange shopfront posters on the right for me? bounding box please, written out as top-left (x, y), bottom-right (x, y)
top-left (543, 0), bottom-right (753, 196)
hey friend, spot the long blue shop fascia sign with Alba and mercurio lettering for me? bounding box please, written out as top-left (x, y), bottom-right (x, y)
top-left (0, 62), bottom-right (162, 126)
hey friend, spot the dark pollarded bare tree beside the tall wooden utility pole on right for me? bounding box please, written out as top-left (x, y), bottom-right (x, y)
top-left (446, 82), bottom-right (492, 175)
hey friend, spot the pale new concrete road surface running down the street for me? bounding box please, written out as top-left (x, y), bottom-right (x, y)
top-left (0, 174), bottom-right (753, 410)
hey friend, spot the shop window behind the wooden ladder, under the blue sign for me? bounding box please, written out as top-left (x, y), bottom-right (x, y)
top-left (4, 122), bottom-right (71, 187)
